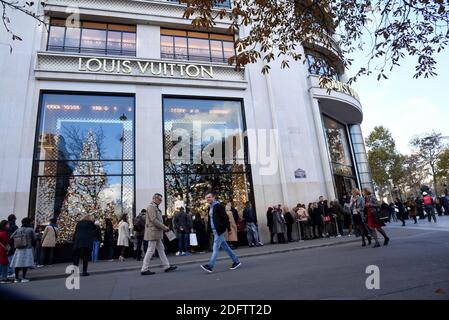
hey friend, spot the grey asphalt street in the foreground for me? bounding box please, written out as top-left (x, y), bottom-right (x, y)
top-left (2, 217), bottom-right (449, 300)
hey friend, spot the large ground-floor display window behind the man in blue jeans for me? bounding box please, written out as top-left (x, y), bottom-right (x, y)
top-left (163, 97), bottom-right (253, 216)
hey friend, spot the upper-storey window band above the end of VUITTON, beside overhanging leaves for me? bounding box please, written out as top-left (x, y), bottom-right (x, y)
top-left (161, 29), bottom-right (235, 63)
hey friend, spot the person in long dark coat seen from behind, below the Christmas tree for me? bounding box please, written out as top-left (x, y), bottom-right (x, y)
top-left (73, 215), bottom-right (96, 276)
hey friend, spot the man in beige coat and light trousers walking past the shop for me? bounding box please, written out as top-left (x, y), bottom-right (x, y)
top-left (140, 193), bottom-right (177, 276)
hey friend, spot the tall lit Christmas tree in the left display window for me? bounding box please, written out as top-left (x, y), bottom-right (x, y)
top-left (59, 130), bottom-right (110, 242)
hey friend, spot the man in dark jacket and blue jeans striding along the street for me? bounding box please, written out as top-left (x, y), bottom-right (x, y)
top-left (201, 193), bottom-right (242, 273)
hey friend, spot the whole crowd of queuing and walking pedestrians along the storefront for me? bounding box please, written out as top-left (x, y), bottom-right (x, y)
top-left (0, 188), bottom-right (449, 283)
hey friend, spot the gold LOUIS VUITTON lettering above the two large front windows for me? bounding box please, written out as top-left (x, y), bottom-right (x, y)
top-left (78, 58), bottom-right (214, 79)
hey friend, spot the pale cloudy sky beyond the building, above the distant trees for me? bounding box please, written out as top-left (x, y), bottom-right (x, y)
top-left (347, 48), bottom-right (449, 154)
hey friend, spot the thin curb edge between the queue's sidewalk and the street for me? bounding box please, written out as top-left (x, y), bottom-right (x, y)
top-left (29, 238), bottom-right (360, 282)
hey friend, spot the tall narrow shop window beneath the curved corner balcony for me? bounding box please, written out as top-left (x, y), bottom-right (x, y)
top-left (323, 115), bottom-right (357, 198)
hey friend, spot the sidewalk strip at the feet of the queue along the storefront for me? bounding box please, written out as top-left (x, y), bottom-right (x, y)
top-left (28, 236), bottom-right (361, 281)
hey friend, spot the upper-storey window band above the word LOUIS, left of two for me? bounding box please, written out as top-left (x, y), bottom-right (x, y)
top-left (47, 19), bottom-right (136, 56)
